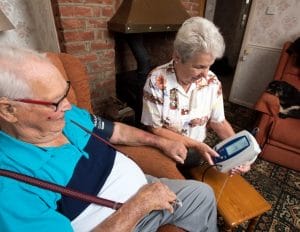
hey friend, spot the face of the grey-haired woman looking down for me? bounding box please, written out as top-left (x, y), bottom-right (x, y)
top-left (174, 53), bottom-right (215, 85)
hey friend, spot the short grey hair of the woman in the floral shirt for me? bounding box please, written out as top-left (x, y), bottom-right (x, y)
top-left (174, 17), bottom-right (225, 63)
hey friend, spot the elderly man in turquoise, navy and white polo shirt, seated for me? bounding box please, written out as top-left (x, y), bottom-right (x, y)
top-left (0, 46), bottom-right (217, 232)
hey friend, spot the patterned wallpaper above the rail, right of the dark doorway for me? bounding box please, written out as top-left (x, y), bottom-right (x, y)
top-left (249, 0), bottom-right (300, 49)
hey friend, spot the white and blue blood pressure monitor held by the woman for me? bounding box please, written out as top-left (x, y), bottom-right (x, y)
top-left (213, 130), bottom-right (261, 172)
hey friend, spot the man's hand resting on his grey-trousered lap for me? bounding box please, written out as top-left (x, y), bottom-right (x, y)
top-left (132, 182), bottom-right (176, 213)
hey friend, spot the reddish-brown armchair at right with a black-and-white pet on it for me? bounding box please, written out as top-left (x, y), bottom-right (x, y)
top-left (255, 42), bottom-right (300, 171)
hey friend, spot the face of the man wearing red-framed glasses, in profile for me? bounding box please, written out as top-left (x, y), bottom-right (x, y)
top-left (15, 64), bottom-right (71, 141)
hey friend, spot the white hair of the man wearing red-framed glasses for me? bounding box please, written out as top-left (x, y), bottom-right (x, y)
top-left (0, 45), bottom-right (47, 99)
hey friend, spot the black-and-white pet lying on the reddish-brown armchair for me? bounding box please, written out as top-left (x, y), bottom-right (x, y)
top-left (266, 81), bottom-right (300, 119)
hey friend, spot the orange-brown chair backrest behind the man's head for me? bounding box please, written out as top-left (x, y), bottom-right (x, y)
top-left (46, 52), bottom-right (93, 113)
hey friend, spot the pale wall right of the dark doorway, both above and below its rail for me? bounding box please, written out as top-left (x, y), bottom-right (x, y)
top-left (229, 0), bottom-right (300, 108)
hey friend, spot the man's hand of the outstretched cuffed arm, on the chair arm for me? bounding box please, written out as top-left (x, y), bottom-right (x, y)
top-left (161, 140), bottom-right (187, 164)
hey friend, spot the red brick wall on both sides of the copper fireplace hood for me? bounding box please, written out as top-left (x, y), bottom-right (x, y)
top-left (52, 0), bottom-right (199, 112)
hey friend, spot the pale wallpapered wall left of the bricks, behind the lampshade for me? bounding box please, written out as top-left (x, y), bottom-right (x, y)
top-left (0, 0), bottom-right (59, 51)
